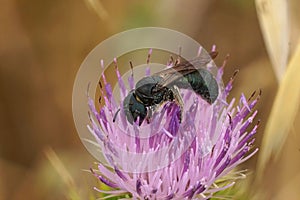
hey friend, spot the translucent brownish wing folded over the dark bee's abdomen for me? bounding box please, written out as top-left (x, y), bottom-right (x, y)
top-left (154, 57), bottom-right (211, 87)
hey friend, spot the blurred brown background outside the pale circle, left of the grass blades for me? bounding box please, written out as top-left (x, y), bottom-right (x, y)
top-left (0, 0), bottom-right (284, 199)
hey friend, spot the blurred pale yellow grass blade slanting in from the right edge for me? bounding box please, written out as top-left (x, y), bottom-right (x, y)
top-left (258, 42), bottom-right (300, 174)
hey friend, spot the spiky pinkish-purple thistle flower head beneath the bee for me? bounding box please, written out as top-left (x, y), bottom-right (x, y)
top-left (88, 48), bottom-right (260, 200)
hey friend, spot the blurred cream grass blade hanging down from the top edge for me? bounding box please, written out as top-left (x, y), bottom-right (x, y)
top-left (255, 0), bottom-right (289, 81)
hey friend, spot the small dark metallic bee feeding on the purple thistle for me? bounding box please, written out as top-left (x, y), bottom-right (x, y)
top-left (123, 52), bottom-right (219, 126)
